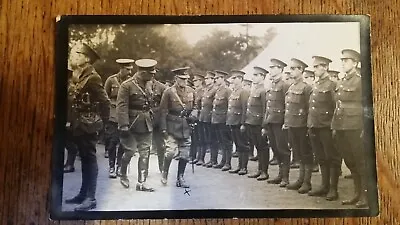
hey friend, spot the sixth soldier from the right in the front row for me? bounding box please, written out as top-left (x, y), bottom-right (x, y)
top-left (226, 70), bottom-right (250, 175)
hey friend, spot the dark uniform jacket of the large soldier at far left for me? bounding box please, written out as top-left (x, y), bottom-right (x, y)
top-left (69, 65), bottom-right (110, 135)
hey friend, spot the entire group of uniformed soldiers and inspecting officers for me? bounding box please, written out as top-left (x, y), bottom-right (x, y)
top-left (66, 41), bottom-right (367, 211)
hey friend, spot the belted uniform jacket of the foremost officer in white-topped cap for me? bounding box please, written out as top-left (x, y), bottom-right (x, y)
top-left (117, 74), bottom-right (153, 133)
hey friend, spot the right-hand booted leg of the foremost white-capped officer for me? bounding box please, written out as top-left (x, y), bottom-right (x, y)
top-left (135, 132), bottom-right (154, 192)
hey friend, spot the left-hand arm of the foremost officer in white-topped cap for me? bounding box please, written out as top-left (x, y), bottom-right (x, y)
top-left (116, 83), bottom-right (129, 128)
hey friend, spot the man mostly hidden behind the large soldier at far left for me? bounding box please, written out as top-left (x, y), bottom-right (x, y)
top-left (64, 65), bottom-right (78, 173)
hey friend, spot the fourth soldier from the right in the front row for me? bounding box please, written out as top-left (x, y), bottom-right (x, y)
top-left (262, 58), bottom-right (290, 187)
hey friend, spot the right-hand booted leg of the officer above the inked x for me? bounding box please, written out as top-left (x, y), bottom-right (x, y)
top-left (176, 137), bottom-right (191, 188)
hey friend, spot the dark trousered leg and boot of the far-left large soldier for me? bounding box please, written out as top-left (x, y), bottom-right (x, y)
top-left (75, 134), bottom-right (99, 211)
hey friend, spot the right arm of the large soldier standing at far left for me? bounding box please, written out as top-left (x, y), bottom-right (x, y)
top-left (87, 75), bottom-right (110, 121)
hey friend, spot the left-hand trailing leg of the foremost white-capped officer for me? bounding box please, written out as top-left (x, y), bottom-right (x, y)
top-left (120, 132), bottom-right (137, 188)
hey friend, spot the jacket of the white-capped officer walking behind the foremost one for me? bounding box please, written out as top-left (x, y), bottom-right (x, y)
top-left (104, 74), bottom-right (128, 123)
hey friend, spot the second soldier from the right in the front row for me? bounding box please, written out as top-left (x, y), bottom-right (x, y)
top-left (307, 56), bottom-right (341, 201)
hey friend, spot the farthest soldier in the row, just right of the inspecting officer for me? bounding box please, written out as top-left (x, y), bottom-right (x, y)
top-left (190, 73), bottom-right (204, 164)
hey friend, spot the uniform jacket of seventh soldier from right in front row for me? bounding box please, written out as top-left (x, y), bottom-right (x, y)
top-left (211, 85), bottom-right (232, 124)
